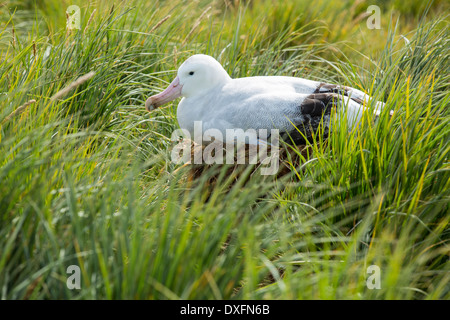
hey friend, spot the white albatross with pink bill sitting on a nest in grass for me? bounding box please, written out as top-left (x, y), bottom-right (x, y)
top-left (145, 54), bottom-right (384, 143)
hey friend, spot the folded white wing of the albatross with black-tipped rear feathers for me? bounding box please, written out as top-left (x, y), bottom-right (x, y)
top-left (208, 77), bottom-right (384, 143)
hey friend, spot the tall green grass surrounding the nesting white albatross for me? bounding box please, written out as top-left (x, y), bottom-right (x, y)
top-left (0, 0), bottom-right (450, 299)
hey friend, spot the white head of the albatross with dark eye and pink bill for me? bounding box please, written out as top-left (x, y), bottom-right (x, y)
top-left (145, 54), bottom-right (231, 111)
